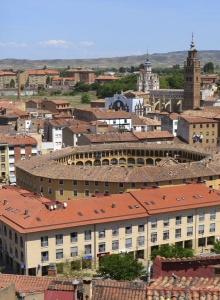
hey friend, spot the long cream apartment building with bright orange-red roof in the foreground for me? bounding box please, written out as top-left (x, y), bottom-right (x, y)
top-left (0, 184), bottom-right (220, 275)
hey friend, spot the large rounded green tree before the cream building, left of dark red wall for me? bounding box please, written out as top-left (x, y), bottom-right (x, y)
top-left (97, 254), bottom-right (144, 280)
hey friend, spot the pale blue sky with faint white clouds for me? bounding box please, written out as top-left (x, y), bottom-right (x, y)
top-left (0, 0), bottom-right (220, 60)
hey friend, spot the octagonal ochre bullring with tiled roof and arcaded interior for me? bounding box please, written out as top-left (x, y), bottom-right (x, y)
top-left (16, 142), bottom-right (220, 201)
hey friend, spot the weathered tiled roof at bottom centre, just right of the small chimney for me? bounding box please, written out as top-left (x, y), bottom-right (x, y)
top-left (92, 280), bottom-right (146, 300)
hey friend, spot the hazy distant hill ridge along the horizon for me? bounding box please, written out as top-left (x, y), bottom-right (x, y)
top-left (0, 50), bottom-right (220, 71)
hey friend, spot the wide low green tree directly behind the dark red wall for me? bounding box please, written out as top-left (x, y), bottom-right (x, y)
top-left (151, 244), bottom-right (194, 260)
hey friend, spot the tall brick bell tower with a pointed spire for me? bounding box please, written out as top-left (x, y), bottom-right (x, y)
top-left (182, 34), bottom-right (200, 110)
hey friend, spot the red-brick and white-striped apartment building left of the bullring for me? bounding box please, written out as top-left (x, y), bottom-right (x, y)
top-left (5, 134), bottom-right (38, 183)
